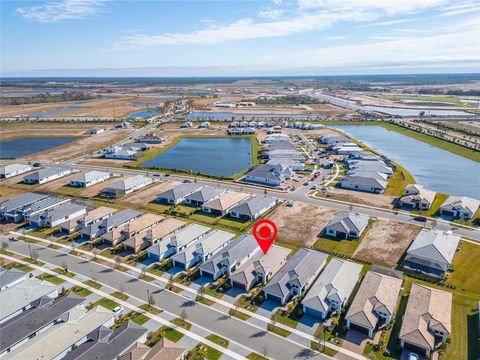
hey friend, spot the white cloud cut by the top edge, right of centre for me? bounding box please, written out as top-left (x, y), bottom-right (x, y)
top-left (298, 0), bottom-right (448, 15)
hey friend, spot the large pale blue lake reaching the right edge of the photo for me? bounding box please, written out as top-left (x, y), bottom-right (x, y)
top-left (332, 125), bottom-right (480, 199)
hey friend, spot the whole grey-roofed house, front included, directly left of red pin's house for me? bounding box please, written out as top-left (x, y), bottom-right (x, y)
top-left (200, 235), bottom-right (260, 280)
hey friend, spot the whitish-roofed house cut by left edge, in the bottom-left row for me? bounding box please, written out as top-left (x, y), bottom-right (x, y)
top-left (0, 278), bottom-right (58, 324)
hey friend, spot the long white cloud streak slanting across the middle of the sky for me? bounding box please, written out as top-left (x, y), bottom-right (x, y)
top-left (112, 11), bottom-right (376, 50)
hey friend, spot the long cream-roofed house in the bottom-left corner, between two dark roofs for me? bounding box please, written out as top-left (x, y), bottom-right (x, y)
top-left (5, 306), bottom-right (114, 360)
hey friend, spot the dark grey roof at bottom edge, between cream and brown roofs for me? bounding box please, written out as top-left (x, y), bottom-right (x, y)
top-left (63, 321), bottom-right (147, 360)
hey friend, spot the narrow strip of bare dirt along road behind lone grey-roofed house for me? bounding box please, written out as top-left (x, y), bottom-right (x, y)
top-left (316, 187), bottom-right (395, 209)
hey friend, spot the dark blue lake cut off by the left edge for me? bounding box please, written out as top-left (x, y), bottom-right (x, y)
top-left (0, 137), bottom-right (78, 159)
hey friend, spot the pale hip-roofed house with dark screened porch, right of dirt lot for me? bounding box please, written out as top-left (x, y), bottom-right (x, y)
top-left (403, 230), bottom-right (460, 278)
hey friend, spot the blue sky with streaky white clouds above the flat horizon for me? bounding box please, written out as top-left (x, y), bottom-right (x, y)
top-left (0, 0), bottom-right (480, 77)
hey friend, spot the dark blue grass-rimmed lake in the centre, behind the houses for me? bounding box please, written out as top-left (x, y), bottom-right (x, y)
top-left (141, 138), bottom-right (252, 177)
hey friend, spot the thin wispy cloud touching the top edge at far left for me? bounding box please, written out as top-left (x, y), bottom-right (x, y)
top-left (16, 0), bottom-right (108, 23)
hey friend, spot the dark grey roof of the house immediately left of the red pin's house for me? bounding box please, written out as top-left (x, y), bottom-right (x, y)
top-left (200, 235), bottom-right (260, 273)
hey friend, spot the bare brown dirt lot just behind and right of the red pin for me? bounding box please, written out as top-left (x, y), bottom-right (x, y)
top-left (268, 202), bottom-right (337, 246)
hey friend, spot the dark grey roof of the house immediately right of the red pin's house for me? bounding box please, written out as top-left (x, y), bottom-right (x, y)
top-left (264, 248), bottom-right (328, 298)
